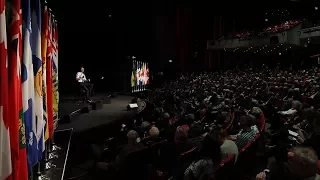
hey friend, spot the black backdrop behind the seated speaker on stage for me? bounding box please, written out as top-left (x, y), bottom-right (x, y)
top-left (49, 1), bottom-right (152, 95)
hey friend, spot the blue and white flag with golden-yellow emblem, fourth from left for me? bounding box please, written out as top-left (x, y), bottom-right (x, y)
top-left (31, 0), bottom-right (46, 160)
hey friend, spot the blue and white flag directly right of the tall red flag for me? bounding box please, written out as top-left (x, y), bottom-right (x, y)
top-left (22, 0), bottom-right (38, 171)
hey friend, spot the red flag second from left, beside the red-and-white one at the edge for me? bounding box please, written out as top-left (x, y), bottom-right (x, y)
top-left (8, 0), bottom-right (28, 180)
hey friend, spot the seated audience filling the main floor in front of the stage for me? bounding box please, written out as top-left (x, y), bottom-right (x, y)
top-left (89, 66), bottom-right (320, 180)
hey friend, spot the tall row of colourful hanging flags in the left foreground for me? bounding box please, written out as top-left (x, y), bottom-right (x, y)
top-left (0, 0), bottom-right (59, 180)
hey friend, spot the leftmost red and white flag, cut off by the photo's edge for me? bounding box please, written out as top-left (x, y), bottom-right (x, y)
top-left (0, 0), bottom-right (12, 180)
